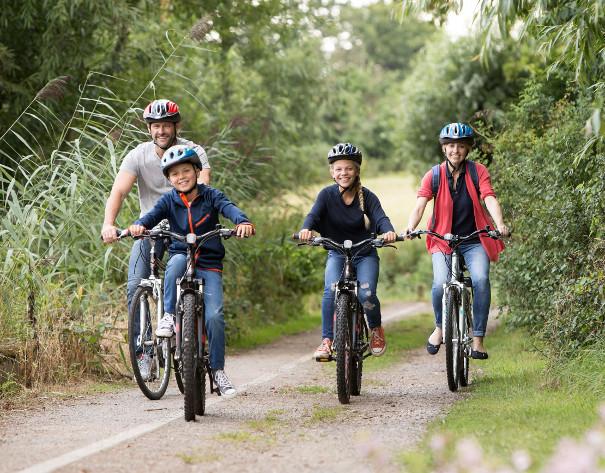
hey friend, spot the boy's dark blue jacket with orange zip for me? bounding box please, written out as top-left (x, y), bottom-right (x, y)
top-left (135, 184), bottom-right (250, 271)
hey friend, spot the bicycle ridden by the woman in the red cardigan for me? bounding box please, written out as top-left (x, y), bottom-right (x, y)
top-left (407, 226), bottom-right (500, 391)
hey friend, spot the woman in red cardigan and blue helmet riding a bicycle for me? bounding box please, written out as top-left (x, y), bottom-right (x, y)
top-left (407, 123), bottom-right (509, 360)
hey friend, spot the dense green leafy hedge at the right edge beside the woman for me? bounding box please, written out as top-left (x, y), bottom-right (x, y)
top-left (494, 74), bottom-right (605, 359)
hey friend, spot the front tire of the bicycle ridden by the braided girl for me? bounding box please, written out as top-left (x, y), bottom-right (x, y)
top-left (334, 292), bottom-right (352, 404)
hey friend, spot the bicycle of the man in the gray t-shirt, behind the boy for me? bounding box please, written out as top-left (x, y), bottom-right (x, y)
top-left (112, 224), bottom-right (184, 401)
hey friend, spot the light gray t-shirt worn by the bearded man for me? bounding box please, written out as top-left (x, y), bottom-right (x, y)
top-left (120, 138), bottom-right (210, 217)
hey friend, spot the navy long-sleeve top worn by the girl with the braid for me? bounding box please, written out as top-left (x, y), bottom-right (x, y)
top-left (303, 184), bottom-right (395, 254)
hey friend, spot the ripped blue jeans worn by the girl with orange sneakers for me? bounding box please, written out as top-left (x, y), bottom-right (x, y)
top-left (321, 251), bottom-right (380, 340)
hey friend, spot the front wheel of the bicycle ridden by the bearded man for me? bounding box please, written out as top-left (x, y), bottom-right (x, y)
top-left (128, 286), bottom-right (171, 401)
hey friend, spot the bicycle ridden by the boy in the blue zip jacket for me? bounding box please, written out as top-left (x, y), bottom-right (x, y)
top-left (168, 225), bottom-right (236, 421)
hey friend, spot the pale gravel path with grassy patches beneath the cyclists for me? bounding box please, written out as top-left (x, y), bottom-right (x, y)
top-left (0, 304), bottom-right (459, 473)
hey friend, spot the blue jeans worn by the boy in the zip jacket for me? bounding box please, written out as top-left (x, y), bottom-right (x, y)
top-left (164, 253), bottom-right (225, 370)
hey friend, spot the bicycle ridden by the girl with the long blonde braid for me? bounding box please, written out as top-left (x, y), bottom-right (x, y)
top-left (292, 233), bottom-right (404, 404)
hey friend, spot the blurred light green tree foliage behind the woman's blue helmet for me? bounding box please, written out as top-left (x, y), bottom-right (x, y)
top-left (391, 37), bottom-right (532, 170)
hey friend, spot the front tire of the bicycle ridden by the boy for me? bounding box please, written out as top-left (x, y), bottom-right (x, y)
top-left (181, 293), bottom-right (198, 422)
